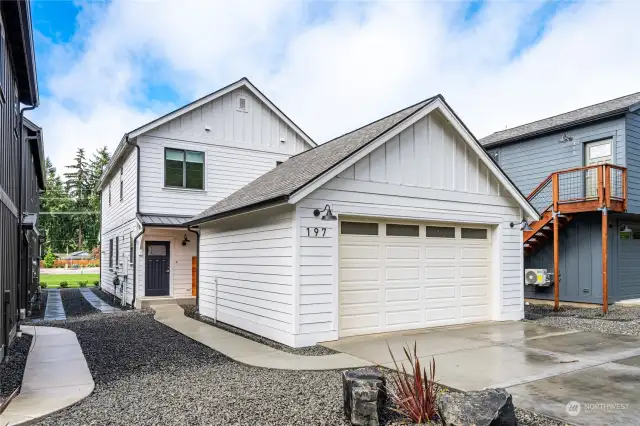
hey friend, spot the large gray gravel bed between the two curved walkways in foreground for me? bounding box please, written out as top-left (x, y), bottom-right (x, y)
top-left (25, 310), bottom-right (559, 426)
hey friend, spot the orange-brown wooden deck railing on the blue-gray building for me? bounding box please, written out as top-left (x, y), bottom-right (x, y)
top-left (527, 164), bottom-right (627, 214)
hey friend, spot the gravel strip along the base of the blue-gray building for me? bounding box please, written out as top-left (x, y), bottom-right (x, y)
top-left (524, 304), bottom-right (640, 336)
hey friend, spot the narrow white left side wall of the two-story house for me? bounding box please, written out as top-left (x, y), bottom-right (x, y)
top-left (100, 149), bottom-right (138, 303)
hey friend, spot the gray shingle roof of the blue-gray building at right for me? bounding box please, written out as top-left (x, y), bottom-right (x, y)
top-left (480, 92), bottom-right (640, 146)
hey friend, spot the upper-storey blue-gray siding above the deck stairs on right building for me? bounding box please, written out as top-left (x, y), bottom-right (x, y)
top-left (487, 118), bottom-right (626, 196)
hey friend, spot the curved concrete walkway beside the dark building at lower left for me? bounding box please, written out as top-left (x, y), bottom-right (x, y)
top-left (0, 326), bottom-right (94, 426)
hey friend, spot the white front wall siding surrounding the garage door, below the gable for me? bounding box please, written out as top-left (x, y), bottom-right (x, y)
top-left (296, 113), bottom-right (523, 346)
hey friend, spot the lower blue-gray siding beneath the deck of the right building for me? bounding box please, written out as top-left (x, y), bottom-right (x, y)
top-left (524, 213), bottom-right (619, 303)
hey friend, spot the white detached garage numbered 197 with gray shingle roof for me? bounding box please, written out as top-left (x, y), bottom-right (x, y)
top-left (188, 95), bottom-right (538, 347)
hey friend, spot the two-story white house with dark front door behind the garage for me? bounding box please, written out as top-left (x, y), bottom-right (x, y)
top-left (100, 78), bottom-right (316, 307)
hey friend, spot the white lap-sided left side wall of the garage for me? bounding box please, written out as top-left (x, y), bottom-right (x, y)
top-left (200, 206), bottom-right (294, 346)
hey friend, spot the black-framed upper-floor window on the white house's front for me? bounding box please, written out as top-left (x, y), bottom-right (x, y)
top-left (164, 148), bottom-right (204, 189)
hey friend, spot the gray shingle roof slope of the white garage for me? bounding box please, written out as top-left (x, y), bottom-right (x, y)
top-left (189, 97), bottom-right (436, 224)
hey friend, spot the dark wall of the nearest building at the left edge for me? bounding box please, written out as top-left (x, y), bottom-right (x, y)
top-left (0, 7), bottom-right (19, 360)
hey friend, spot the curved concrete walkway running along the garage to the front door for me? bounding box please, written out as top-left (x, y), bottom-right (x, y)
top-left (151, 305), bottom-right (373, 370)
